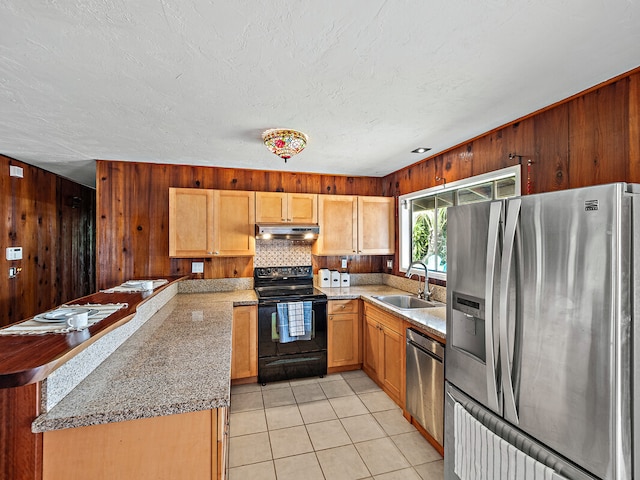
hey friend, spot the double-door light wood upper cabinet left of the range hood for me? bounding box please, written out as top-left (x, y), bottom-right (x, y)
top-left (169, 188), bottom-right (255, 258)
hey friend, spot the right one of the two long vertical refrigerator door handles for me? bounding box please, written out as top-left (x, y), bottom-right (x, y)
top-left (500, 199), bottom-right (521, 425)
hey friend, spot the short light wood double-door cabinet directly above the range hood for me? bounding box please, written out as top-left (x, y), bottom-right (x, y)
top-left (256, 192), bottom-right (318, 224)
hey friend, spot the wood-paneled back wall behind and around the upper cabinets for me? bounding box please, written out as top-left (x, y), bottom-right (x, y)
top-left (96, 161), bottom-right (382, 288)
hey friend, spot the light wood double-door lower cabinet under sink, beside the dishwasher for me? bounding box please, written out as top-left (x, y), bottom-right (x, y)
top-left (362, 303), bottom-right (405, 408)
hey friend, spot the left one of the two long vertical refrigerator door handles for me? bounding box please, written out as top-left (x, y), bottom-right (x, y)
top-left (484, 202), bottom-right (503, 412)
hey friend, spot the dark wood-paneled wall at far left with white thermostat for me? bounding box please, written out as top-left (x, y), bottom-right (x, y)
top-left (0, 155), bottom-right (95, 326)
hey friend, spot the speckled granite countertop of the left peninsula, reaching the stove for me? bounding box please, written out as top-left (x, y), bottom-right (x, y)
top-left (32, 290), bottom-right (257, 433)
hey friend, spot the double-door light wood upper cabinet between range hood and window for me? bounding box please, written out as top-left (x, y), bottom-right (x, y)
top-left (313, 195), bottom-right (395, 255)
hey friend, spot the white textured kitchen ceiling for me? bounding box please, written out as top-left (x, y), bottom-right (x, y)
top-left (0, 0), bottom-right (640, 185)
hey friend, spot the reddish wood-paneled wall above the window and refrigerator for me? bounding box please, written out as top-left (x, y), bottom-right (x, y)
top-left (383, 68), bottom-right (640, 195)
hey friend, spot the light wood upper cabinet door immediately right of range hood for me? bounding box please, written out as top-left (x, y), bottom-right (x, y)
top-left (313, 195), bottom-right (358, 255)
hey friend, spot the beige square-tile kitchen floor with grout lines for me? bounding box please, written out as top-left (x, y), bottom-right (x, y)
top-left (229, 370), bottom-right (443, 480)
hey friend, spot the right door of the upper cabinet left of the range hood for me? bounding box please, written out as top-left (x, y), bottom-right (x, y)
top-left (214, 190), bottom-right (256, 257)
